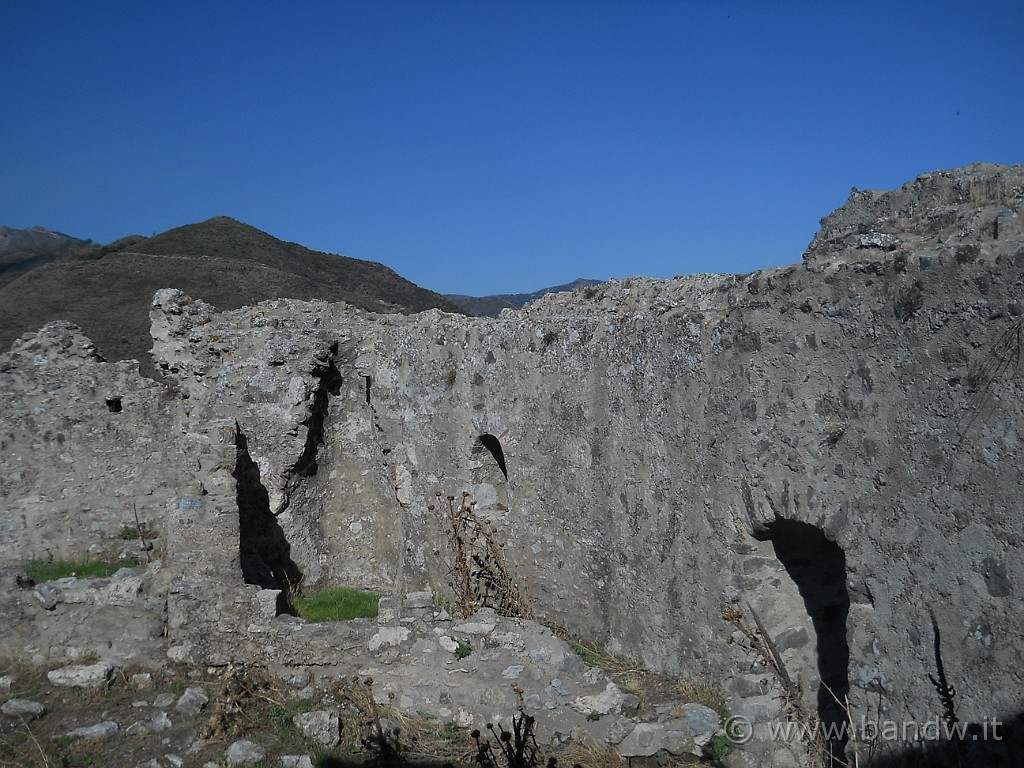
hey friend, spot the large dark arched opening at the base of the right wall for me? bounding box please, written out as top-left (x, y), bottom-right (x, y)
top-left (758, 519), bottom-right (850, 765)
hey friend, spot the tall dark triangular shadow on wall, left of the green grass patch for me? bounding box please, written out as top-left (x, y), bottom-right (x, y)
top-left (232, 427), bottom-right (302, 592)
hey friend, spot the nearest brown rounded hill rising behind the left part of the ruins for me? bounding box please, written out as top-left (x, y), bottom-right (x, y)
top-left (0, 216), bottom-right (465, 371)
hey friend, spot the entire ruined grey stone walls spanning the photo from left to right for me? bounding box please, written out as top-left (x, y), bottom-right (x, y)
top-left (0, 165), bottom-right (1024, 765)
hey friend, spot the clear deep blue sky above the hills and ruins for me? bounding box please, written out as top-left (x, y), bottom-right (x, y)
top-left (0, 0), bottom-right (1024, 295)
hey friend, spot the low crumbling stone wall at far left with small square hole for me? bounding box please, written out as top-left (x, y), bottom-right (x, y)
top-left (0, 323), bottom-right (186, 563)
